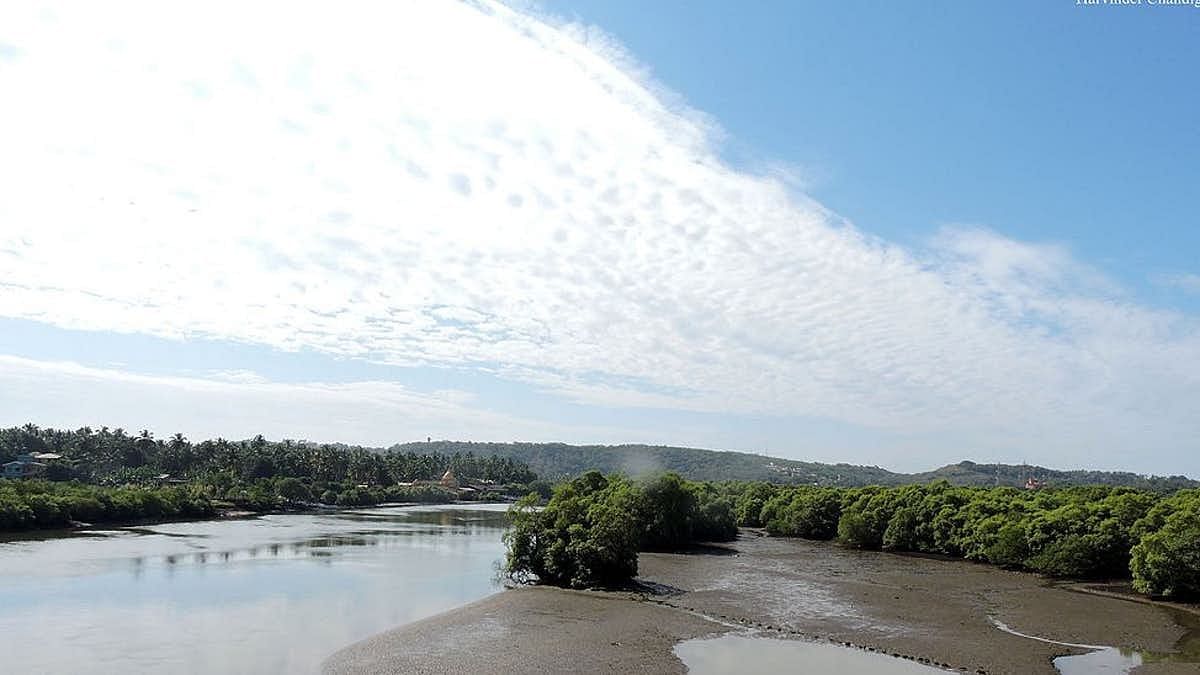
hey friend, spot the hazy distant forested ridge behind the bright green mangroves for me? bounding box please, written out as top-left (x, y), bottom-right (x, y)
top-left (390, 441), bottom-right (1200, 490)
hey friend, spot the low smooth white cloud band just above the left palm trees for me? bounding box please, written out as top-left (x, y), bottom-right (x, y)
top-left (0, 356), bottom-right (629, 446)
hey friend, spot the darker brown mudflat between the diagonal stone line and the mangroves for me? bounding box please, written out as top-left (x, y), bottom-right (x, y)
top-left (640, 532), bottom-right (1200, 674)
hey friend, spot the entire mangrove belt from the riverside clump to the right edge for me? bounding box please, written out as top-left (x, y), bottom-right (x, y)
top-left (506, 471), bottom-right (1200, 599)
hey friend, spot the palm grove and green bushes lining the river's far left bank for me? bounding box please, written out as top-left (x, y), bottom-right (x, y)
top-left (0, 425), bottom-right (537, 530)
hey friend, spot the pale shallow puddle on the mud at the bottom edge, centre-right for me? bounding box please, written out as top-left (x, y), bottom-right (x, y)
top-left (674, 635), bottom-right (946, 675)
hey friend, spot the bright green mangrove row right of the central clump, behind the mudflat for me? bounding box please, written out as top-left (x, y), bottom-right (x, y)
top-left (726, 480), bottom-right (1200, 598)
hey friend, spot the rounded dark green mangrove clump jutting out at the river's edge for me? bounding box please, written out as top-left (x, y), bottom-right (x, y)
top-left (505, 471), bottom-right (737, 589)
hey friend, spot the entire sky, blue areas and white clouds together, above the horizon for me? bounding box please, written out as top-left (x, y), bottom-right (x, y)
top-left (0, 0), bottom-right (1200, 477)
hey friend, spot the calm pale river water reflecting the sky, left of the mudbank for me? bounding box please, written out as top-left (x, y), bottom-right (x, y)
top-left (0, 504), bottom-right (505, 673)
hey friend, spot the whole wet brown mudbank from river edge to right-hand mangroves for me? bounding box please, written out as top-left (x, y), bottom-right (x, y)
top-left (325, 531), bottom-right (1200, 675)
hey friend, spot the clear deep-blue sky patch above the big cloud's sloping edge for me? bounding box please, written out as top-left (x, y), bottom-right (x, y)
top-left (544, 0), bottom-right (1200, 289)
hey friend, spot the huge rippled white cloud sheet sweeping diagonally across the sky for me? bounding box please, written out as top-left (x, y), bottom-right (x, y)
top-left (0, 2), bottom-right (1200, 473)
